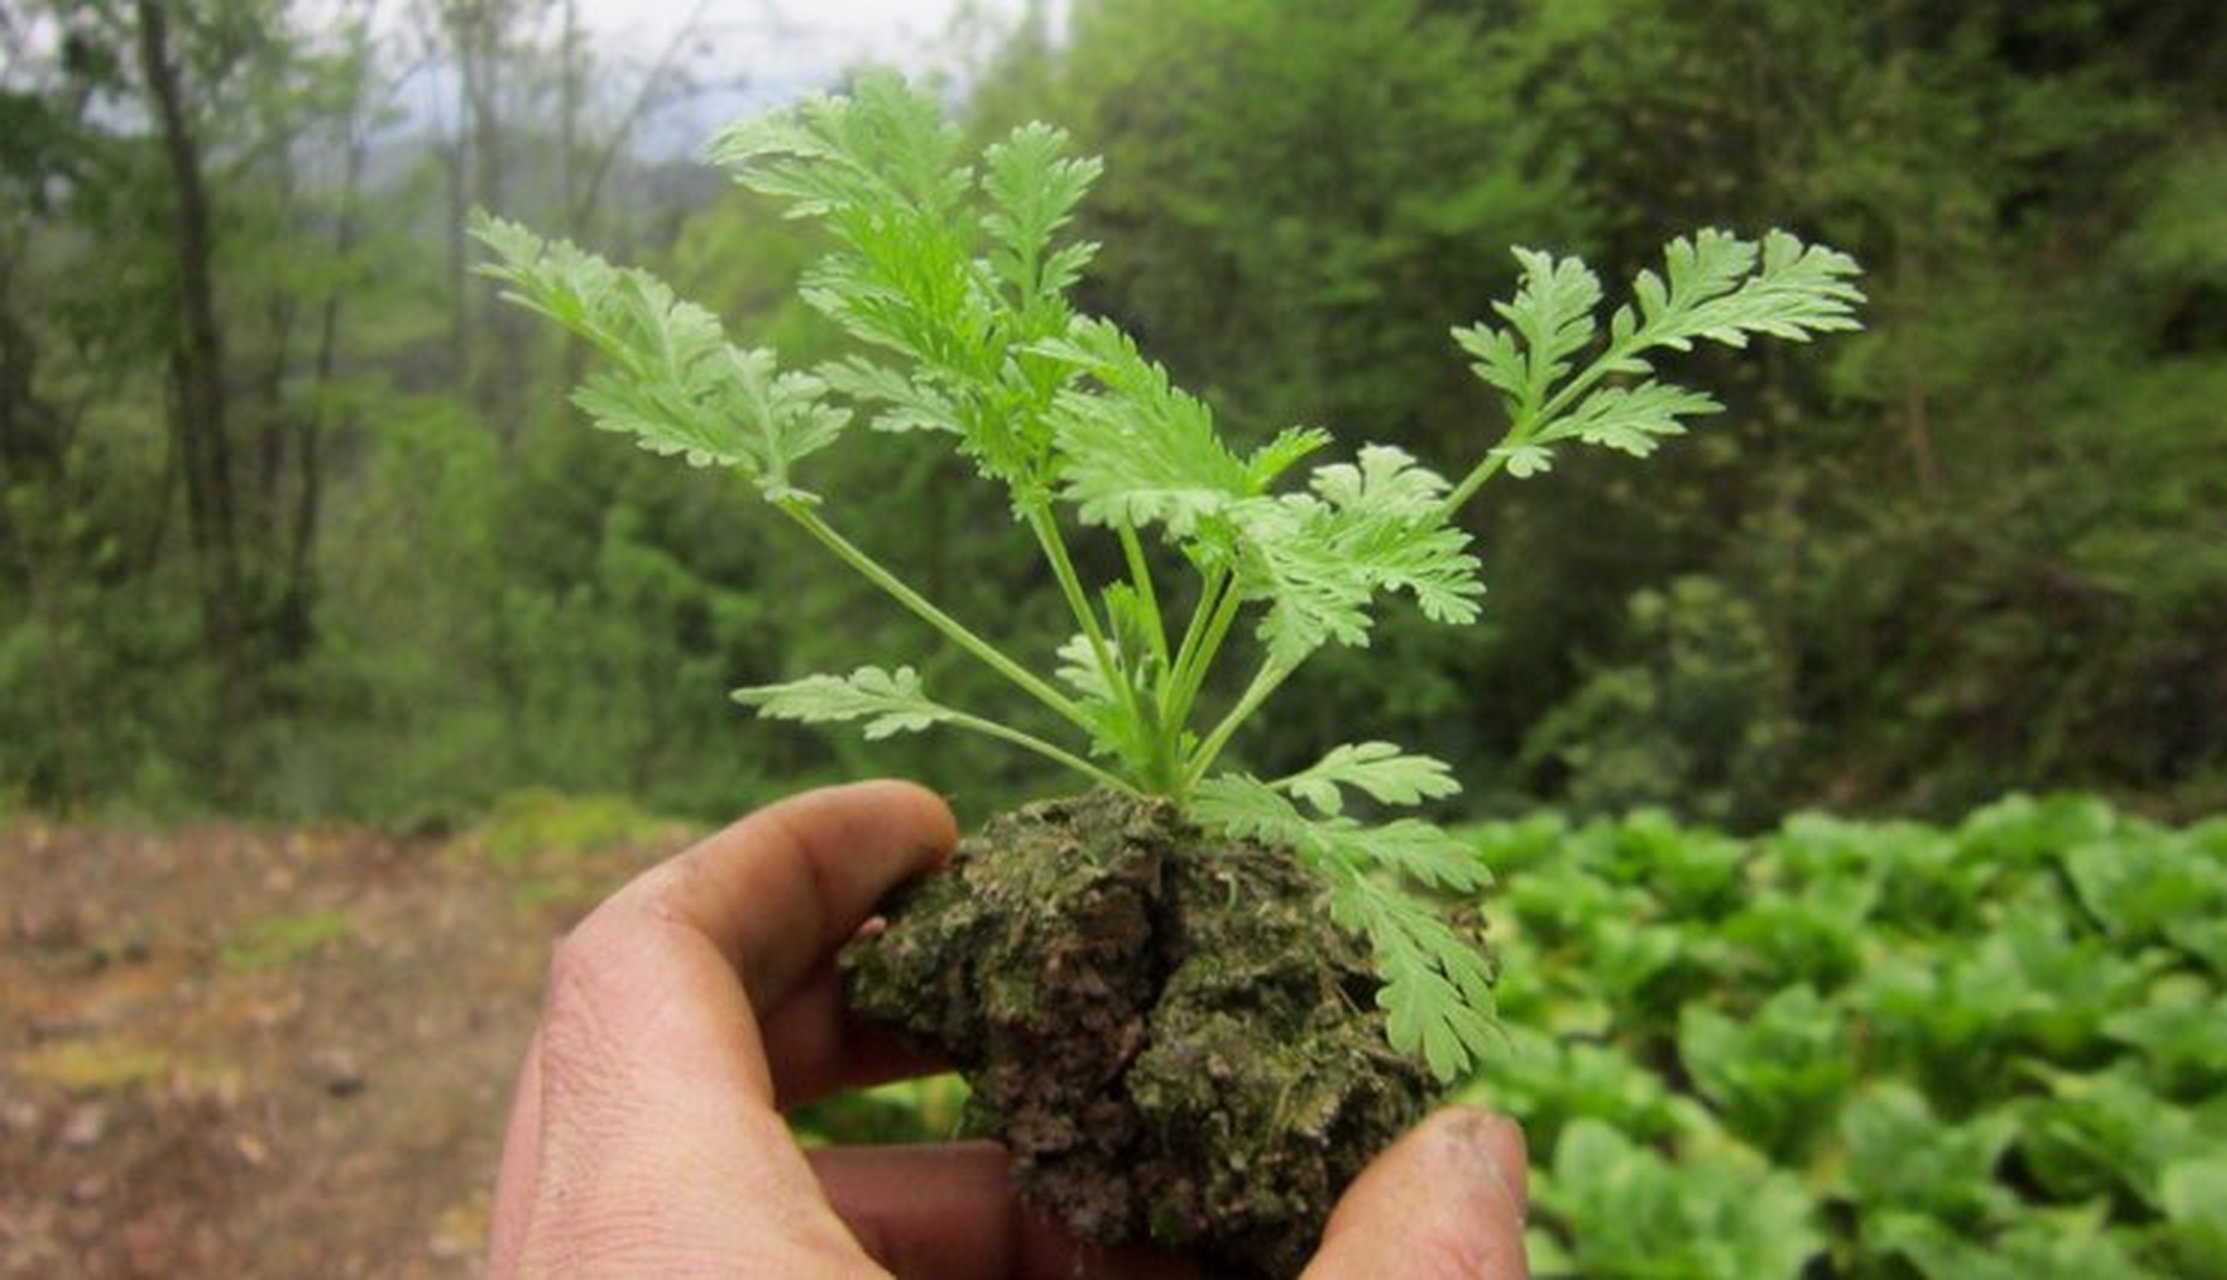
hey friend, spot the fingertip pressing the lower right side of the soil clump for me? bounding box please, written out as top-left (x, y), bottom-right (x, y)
top-left (1305, 1106), bottom-right (1530, 1280)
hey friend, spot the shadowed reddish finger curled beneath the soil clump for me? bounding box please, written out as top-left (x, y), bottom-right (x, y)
top-left (811, 1142), bottom-right (1198, 1280)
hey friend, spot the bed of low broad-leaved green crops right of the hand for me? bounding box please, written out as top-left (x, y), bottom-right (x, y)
top-left (1465, 797), bottom-right (2227, 1280)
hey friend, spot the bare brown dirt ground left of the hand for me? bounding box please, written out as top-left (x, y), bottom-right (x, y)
top-left (0, 821), bottom-right (679, 1276)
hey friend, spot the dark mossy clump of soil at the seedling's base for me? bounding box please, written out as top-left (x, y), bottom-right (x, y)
top-left (844, 792), bottom-right (1432, 1278)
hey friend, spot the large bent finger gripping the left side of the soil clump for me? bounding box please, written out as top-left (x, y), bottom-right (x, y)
top-left (521, 784), bottom-right (953, 1276)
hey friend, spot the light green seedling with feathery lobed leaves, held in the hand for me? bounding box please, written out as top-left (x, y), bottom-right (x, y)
top-left (487, 76), bottom-right (1862, 1080)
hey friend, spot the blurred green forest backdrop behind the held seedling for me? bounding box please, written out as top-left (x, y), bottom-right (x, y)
top-left (0, 0), bottom-right (2227, 828)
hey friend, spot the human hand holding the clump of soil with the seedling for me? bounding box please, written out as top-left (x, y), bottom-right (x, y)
top-left (490, 784), bottom-right (1525, 1280)
